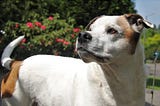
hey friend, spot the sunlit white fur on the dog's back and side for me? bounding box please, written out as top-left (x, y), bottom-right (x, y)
top-left (3, 55), bottom-right (116, 106)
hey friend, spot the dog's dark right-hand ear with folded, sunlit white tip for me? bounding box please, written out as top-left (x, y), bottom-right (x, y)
top-left (125, 14), bottom-right (154, 33)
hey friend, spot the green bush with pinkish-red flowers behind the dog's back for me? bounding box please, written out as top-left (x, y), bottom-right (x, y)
top-left (1, 14), bottom-right (82, 58)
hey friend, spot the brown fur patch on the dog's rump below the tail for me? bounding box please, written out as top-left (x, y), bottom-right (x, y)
top-left (1, 61), bottom-right (22, 98)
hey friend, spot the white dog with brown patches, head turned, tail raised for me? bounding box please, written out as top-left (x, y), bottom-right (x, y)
top-left (1, 14), bottom-right (154, 106)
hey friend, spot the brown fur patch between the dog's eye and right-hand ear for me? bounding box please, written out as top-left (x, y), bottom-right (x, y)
top-left (117, 16), bottom-right (139, 54)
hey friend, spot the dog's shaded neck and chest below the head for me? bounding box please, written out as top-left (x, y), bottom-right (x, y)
top-left (101, 43), bottom-right (145, 106)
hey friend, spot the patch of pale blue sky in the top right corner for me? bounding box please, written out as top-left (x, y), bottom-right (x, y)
top-left (132, 0), bottom-right (160, 26)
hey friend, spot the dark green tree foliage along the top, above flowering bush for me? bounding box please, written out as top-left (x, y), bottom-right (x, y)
top-left (0, 0), bottom-right (136, 28)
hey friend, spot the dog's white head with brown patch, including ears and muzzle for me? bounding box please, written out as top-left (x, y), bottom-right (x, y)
top-left (76, 14), bottom-right (154, 62)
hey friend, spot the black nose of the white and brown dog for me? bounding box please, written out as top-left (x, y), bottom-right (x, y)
top-left (78, 32), bottom-right (92, 43)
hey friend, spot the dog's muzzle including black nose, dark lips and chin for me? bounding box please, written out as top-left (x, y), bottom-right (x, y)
top-left (76, 32), bottom-right (109, 63)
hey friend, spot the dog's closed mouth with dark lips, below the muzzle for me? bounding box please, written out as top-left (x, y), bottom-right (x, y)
top-left (77, 47), bottom-right (110, 62)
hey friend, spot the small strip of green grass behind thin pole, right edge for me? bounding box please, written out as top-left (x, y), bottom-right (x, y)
top-left (147, 76), bottom-right (160, 90)
